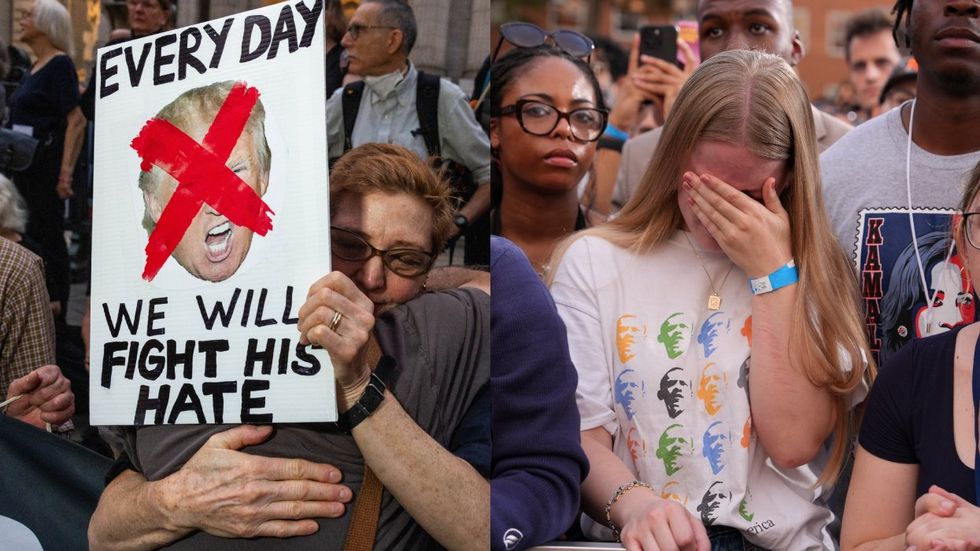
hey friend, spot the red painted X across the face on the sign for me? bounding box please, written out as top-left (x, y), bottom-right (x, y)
top-left (131, 82), bottom-right (275, 281)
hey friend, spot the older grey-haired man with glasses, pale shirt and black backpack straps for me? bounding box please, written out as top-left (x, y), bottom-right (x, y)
top-left (327, 0), bottom-right (490, 264)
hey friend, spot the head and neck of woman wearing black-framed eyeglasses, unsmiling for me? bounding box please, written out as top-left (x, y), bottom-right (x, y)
top-left (490, 46), bottom-right (607, 276)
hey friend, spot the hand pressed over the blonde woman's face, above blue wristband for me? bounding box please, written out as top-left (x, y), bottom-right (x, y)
top-left (683, 172), bottom-right (793, 278)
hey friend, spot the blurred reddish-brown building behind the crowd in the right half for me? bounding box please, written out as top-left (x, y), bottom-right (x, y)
top-left (492, 0), bottom-right (893, 103)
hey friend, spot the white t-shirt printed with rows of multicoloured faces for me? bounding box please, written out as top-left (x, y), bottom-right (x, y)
top-left (551, 232), bottom-right (834, 550)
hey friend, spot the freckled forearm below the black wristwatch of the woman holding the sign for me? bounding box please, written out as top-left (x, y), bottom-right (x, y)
top-left (353, 392), bottom-right (490, 550)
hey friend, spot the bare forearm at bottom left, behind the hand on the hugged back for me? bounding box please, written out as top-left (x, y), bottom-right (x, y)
top-left (88, 471), bottom-right (190, 551)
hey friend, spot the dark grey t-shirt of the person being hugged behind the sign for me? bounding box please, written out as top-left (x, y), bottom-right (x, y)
top-left (123, 289), bottom-right (490, 551)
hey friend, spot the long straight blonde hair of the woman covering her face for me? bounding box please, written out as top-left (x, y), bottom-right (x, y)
top-left (551, 50), bottom-right (874, 483)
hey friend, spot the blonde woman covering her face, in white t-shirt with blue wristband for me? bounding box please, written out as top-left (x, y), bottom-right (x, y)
top-left (550, 50), bottom-right (870, 551)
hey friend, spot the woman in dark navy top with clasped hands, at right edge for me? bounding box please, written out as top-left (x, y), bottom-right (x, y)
top-left (841, 163), bottom-right (980, 551)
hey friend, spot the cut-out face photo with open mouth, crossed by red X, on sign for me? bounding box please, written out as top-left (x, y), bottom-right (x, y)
top-left (133, 81), bottom-right (272, 282)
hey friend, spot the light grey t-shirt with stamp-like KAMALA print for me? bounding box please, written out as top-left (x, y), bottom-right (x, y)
top-left (820, 103), bottom-right (980, 362)
